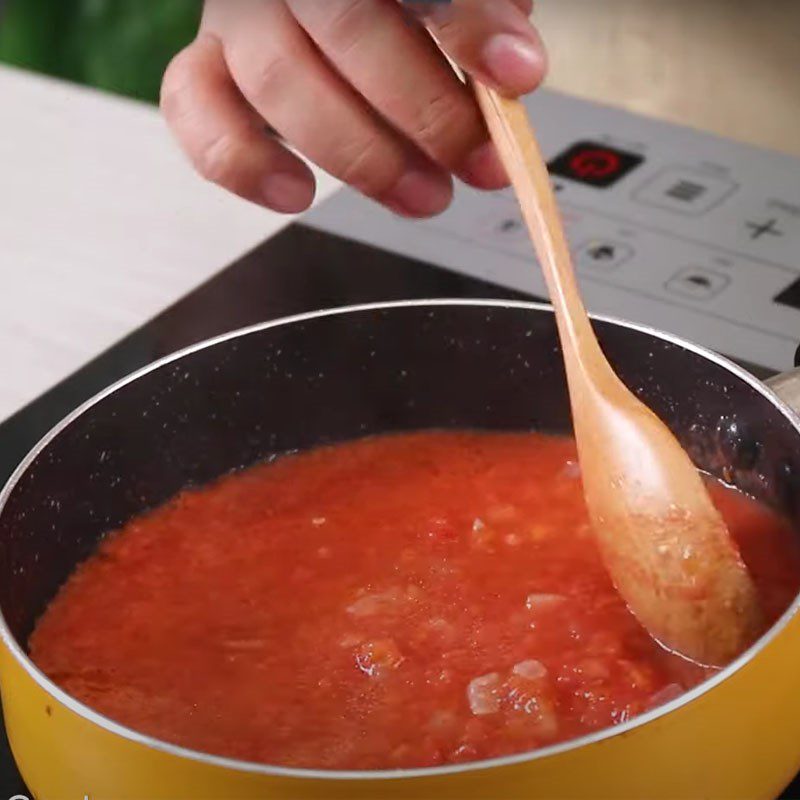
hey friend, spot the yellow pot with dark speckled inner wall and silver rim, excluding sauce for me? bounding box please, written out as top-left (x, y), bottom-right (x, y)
top-left (0, 301), bottom-right (800, 800)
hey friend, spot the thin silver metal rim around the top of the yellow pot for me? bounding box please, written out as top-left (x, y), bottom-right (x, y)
top-left (0, 298), bottom-right (800, 781)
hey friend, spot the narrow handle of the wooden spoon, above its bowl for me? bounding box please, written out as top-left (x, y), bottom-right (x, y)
top-left (473, 82), bottom-right (605, 376)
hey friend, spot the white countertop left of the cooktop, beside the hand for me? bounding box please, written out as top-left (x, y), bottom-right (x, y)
top-left (0, 66), bottom-right (337, 419)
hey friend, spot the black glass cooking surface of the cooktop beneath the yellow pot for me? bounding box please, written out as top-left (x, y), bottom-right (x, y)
top-left (0, 224), bottom-right (800, 800)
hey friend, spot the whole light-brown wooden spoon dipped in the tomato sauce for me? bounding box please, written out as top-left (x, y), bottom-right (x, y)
top-left (475, 84), bottom-right (763, 666)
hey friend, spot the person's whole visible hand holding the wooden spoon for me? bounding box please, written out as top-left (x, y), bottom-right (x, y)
top-left (161, 0), bottom-right (545, 217)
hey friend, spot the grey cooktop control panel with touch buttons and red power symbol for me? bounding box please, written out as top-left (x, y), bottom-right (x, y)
top-left (305, 91), bottom-right (800, 370)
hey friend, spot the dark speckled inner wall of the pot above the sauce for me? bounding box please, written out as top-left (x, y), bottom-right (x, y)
top-left (0, 303), bottom-right (800, 645)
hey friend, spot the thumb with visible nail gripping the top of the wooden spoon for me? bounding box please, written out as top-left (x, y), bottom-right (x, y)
top-left (404, 0), bottom-right (547, 96)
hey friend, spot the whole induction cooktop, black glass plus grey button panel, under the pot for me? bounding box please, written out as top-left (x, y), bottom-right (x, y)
top-left (0, 87), bottom-right (800, 800)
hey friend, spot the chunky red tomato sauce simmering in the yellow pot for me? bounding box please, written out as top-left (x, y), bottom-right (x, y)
top-left (30, 432), bottom-right (800, 769)
